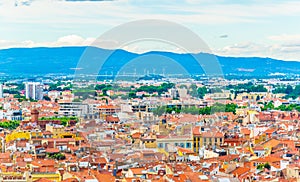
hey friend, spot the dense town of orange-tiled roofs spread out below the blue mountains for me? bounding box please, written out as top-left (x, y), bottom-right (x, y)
top-left (0, 78), bottom-right (300, 182)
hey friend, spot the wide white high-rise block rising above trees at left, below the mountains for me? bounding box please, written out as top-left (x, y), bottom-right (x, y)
top-left (25, 82), bottom-right (43, 100)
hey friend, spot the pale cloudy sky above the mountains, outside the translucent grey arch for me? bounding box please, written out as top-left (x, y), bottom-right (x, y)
top-left (0, 0), bottom-right (300, 61)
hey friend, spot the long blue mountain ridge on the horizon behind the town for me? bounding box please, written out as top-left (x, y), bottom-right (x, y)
top-left (0, 47), bottom-right (300, 77)
